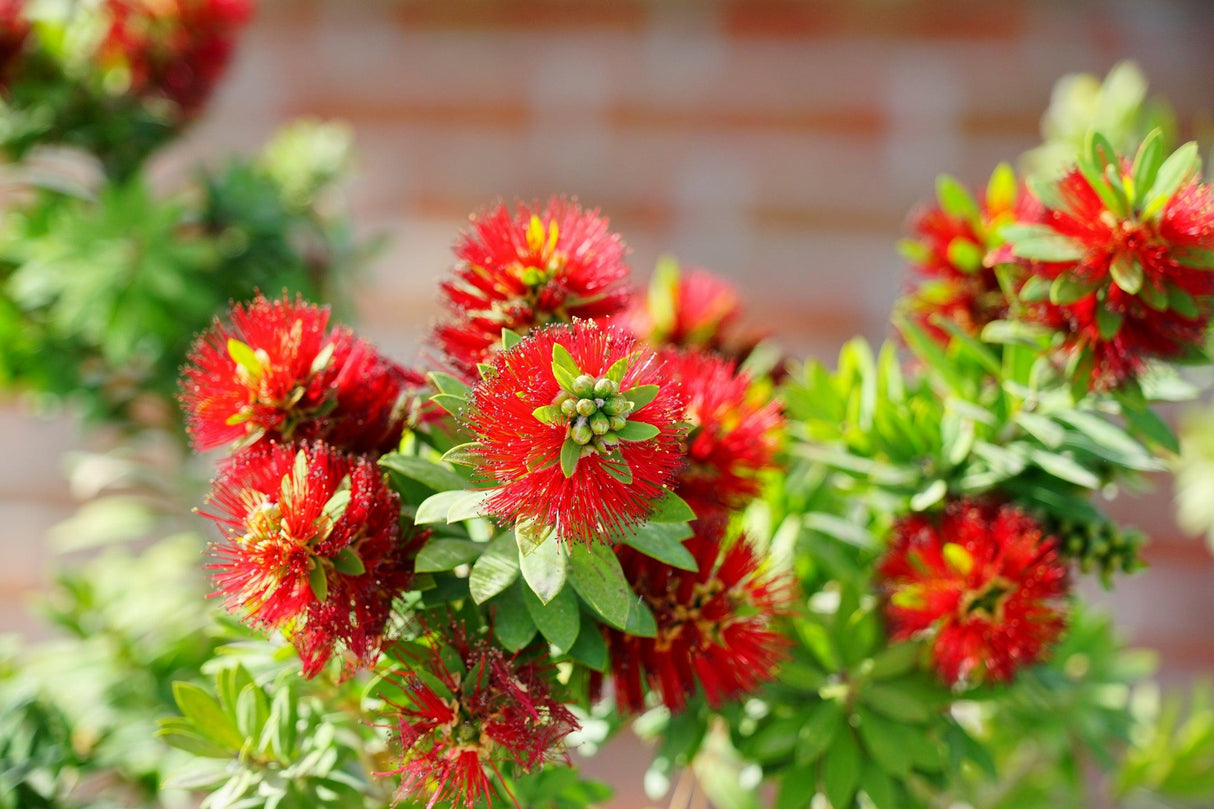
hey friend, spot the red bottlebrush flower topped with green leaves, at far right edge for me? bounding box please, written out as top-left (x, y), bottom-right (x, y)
top-left (1002, 137), bottom-right (1214, 390)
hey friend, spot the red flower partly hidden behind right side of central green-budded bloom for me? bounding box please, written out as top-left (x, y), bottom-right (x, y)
top-left (662, 351), bottom-right (783, 516)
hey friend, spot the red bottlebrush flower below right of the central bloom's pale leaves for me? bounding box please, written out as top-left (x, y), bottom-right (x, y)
top-left (603, 519), bottom-right (794, 712)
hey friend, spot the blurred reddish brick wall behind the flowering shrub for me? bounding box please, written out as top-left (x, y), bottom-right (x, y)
top-left (0, 0), bottom-right (1214, 805)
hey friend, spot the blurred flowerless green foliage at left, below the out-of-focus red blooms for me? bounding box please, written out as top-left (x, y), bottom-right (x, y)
top-left (0, 118), bottom-right (364, 425)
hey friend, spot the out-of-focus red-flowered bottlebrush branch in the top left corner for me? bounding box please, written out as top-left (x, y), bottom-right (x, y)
top-left (0, 0), bottom-right (254, 179)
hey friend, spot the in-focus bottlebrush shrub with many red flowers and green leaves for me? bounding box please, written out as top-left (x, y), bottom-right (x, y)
top-left (161, 83), bottom-right (1214, 809)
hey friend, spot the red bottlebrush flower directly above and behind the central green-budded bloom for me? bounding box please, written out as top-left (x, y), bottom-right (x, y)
top-left (435, 198), bottom-right (630, 379)
